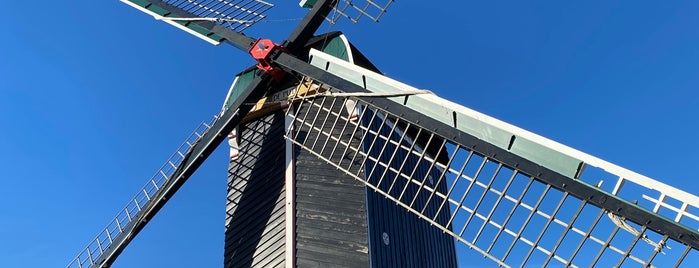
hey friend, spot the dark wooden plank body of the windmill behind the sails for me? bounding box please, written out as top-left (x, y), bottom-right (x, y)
top-left (225, 33), bottom-right (456, 267)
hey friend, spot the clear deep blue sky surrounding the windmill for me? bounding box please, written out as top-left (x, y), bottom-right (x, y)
top-left (0, 0), bottom-right (699, 267)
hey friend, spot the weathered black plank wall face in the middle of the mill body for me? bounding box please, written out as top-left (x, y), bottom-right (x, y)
top-left (294, 100), bottom-right (369, 267)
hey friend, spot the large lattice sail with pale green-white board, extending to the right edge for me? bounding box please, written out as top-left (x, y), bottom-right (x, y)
top-left (276, 47), bottom-right (699, 266)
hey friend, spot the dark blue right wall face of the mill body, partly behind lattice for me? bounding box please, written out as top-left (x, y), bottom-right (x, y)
top-left (361, 110), bottom-right (457, 267)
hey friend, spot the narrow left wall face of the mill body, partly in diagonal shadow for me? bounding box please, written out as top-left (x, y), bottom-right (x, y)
top-left (224, 113), bottom-right (285, 267)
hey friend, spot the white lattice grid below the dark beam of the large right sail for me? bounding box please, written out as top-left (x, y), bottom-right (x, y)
top-left (286, 83), bottom-right (699, 267)
